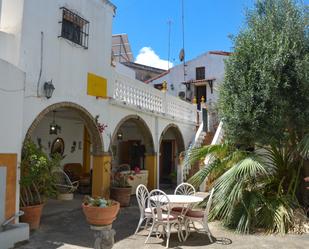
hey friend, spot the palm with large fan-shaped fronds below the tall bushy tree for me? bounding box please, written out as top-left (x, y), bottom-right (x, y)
top-left (189, 136), bottom-right (309, 233)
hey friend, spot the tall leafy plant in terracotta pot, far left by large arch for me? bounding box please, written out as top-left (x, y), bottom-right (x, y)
top-left (20, 140), bottom-right (61, 229)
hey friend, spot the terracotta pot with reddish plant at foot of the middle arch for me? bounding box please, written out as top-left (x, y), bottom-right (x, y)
top-left (110, 172), bottom-right (132, 207)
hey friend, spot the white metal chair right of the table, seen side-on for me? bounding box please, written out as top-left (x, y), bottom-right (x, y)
top-left (185, 188), bottom-right (214, 243)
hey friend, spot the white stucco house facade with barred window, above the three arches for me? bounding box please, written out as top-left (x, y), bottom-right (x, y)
top-left (0, 0), bottom-right (195, 198)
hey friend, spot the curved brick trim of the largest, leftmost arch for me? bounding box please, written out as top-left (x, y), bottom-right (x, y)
top-left (25, 102), bottom-right (104, 156)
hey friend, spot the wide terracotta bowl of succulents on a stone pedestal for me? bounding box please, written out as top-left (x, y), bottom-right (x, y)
top-left (82, 196), bottom-right (120, 226)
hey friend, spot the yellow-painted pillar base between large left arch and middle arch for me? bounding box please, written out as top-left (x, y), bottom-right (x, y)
top-left (92, 154), bottom-right (112, 198)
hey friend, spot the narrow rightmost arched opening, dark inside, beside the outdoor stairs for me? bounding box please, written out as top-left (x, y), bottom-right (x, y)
top-left (159, 124), bottom-right (185, 189)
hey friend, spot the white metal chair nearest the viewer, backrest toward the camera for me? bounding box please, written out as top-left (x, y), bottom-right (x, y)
top-left (145, 189), bottom-right (181, 248)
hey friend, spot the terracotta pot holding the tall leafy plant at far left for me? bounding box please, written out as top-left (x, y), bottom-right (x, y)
top-left (20, 204), bottom-right (44, 229)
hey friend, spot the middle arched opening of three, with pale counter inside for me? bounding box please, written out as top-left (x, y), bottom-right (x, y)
top-left (110, 115), bottom-right (156, 191)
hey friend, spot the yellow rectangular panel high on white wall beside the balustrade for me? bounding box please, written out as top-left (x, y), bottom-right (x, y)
top-left (87, 73), bottom-right (107, 98)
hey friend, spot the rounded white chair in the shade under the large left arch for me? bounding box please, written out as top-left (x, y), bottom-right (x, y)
top-left (52, 168), bottom-right (79, 193)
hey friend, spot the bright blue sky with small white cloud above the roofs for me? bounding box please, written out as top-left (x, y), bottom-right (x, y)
top-left (112, 0), bottom-right (309, 69)
